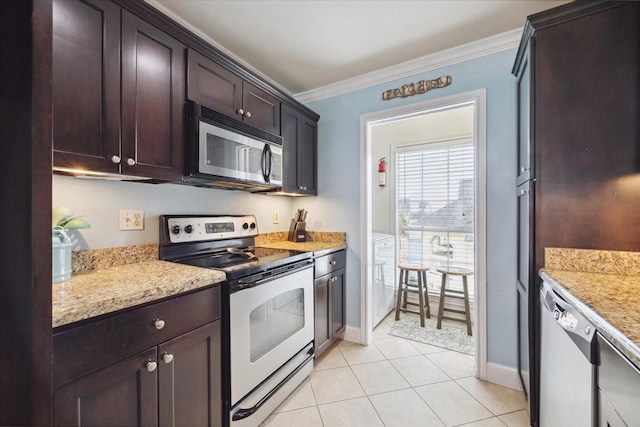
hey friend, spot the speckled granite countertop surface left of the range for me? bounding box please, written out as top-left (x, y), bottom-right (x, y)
top-left (52, 260), bottom-right (226, 328)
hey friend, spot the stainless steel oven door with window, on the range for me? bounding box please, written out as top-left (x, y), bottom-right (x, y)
top-left (229, 265), bottom-right (314, 407)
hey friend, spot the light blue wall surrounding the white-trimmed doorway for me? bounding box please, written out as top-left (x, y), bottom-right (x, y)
top-left (302, 49), bottom-right (517, 367)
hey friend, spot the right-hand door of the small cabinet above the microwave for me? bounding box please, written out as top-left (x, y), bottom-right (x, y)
top-left (242, 82), bottom-right (280, 135)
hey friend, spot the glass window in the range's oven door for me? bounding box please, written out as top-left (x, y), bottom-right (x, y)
top-left (249, 288), bottom-right (304, 363)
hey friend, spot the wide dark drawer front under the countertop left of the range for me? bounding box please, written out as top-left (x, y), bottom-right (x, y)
top-left (53, 286), bottom-right (220, 385)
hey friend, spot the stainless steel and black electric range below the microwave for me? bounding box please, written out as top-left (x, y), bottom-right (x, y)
top-left (159, 215), bottom-right (314, 426)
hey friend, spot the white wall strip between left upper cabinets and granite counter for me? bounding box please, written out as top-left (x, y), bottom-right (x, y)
top-left (53, 175), bottom-right (294, 250)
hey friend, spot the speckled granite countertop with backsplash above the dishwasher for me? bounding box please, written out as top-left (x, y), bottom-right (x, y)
top-left (540, 248), bottom-right (640, 366)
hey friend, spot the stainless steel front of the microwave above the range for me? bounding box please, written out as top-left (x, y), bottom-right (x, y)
top-left (198, 121), bottom-right (282, 186)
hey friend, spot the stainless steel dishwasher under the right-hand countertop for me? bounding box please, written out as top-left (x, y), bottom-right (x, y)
top-left (540, 282), bottom-right (597, 427)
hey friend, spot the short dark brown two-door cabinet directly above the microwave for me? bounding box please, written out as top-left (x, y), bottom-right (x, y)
top-left (187, 49), bottom-right (280, 135)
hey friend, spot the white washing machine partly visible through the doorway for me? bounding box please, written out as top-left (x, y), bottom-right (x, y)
top-left (371, 232), bottom-right (396, 327)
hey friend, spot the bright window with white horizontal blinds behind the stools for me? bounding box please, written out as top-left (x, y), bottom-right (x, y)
top-left (395, 138), bottom-right (475, 299)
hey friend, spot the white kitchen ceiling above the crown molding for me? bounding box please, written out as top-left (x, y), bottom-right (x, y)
top-left (147, 0), bottom-right (568, 94)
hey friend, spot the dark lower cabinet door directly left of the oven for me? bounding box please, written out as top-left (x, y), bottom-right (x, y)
top-left (158, 321), bottom-right (222, 427)
